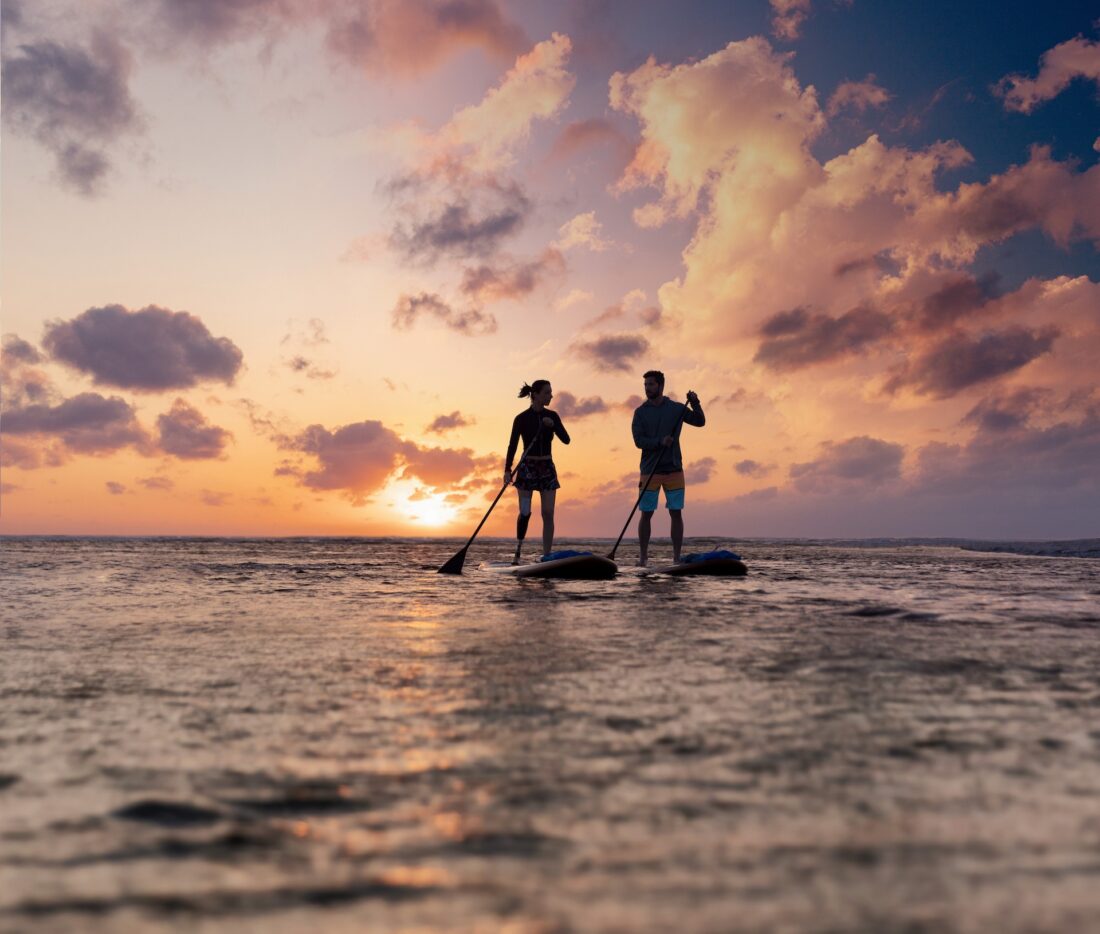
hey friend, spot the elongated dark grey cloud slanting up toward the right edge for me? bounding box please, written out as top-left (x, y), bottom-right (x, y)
top-left (884, 327), bottom-right (1058, 398)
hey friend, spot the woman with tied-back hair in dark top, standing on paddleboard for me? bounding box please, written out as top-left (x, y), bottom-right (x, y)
top-left (504, 380), bottom-right (569, 564)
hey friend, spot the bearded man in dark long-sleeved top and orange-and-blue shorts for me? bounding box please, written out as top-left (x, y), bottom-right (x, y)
top-left (630, 370), bottom-right (706, 568)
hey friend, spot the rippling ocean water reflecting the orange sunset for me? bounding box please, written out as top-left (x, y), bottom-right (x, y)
top-left (0, 538), bottom-right (1100, 932)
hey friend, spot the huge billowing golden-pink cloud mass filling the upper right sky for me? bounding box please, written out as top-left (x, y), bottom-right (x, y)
top-left (611, 39), bottom-right (1100, 415)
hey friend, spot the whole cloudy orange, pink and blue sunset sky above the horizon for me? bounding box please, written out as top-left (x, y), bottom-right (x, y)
top-left (0, 0), bottom-right (1100, 540)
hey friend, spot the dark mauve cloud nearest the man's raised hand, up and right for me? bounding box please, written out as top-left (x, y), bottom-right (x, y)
top-left (754, 308), bottom-right (893, 370)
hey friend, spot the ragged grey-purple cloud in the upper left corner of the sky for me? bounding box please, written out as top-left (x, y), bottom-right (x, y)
top-left (0, 33), bottom-right (142, 196)
